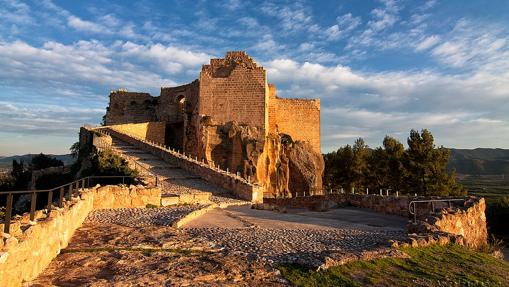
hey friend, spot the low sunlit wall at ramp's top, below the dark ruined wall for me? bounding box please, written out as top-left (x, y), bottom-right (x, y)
top-left (111, 122), bottom-right (166, 144)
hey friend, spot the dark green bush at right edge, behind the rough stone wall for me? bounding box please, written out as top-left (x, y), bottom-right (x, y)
top-left (486, 196), bottom-right (509, 235)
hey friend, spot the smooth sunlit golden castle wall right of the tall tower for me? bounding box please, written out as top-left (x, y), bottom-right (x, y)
top-left (269, 98), bottom-right (320, 153)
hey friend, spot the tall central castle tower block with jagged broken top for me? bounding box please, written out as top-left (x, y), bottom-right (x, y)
top-left (199, 52), bottom-right (268, 129)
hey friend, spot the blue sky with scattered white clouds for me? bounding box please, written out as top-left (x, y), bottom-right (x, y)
top-left (0, 0), bottom-right (509, 155)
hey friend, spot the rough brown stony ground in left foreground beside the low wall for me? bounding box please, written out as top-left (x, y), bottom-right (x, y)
top-left (29, 207), bottom-right (288, 287)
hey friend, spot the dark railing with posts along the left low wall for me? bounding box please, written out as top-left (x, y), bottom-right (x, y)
top-left (0, 175), bottom-right (134, 233)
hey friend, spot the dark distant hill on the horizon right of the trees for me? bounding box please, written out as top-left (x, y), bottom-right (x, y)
top-left (448, 148), bottom-right (509, 175)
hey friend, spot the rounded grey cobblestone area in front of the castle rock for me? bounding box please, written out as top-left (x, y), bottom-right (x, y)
top-left (186, 207), bottom-right (406, 267)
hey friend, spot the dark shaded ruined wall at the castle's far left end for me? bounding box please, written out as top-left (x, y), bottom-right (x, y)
top-left (105, 91), bottom-right (158, 125)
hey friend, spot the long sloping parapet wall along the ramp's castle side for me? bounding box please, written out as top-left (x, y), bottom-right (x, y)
top-left (102, 128), bottom-right (263, 203)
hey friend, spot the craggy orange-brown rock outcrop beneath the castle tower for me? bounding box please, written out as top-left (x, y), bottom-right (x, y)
top-left (202, 119), bottom-right (324, 197)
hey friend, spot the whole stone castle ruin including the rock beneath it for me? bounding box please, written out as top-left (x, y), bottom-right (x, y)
top-left (105, 51), bottom-right (324, 197)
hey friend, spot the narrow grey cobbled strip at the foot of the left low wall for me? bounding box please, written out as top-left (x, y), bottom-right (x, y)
top-left (86, 205), bottom-right (204, 227)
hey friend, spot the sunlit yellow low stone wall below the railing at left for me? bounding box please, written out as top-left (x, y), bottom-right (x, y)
top-left (0, 186), bottom-right (161, 286)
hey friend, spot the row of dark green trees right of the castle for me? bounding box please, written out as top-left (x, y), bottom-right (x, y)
top-left (324, 129), bottom-right (466, 196)
